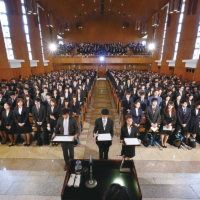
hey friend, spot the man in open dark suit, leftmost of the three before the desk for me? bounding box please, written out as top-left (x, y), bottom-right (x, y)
top-left (52, 108), bottom-right (79, 170)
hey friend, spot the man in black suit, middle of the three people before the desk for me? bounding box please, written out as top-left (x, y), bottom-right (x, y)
top-left (93, 109), bottom-right (114, 159)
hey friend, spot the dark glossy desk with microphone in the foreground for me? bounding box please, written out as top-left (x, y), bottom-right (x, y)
top-left (61, 159), bottom-right (142, 200)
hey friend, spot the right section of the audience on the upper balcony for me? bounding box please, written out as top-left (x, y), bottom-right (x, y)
top-left (128, 42), bottom-right (150, 55)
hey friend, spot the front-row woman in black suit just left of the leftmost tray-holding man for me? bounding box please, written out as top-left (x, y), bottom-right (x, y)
top-left (47, 99), bottom-right (60, 142)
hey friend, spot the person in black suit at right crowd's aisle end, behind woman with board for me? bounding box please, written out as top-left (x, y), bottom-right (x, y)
top-left (121, 91), bottom-right (133, 119)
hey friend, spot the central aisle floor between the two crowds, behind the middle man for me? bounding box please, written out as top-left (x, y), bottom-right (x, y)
top-left (80, 80), bottom-right (121, 159)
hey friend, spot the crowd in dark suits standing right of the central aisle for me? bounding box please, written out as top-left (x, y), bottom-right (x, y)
top-left (107, 70), bottom-right (200, 147)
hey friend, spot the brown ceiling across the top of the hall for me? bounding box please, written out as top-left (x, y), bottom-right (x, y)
top-left (37, 0), bottom-right (169, 25)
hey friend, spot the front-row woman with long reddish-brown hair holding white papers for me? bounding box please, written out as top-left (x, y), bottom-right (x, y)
top-left (160, 101), bottom-right (176, 148)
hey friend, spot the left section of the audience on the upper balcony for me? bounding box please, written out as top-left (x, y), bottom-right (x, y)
top-left (54, 43), bottom-right (77, 55)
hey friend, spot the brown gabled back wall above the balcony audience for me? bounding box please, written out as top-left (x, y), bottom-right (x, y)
top-left (64, 15), bottom-right (141, 44)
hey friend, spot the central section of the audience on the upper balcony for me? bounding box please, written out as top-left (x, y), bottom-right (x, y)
top-left (77, 42), bottom-right (127, 55)
